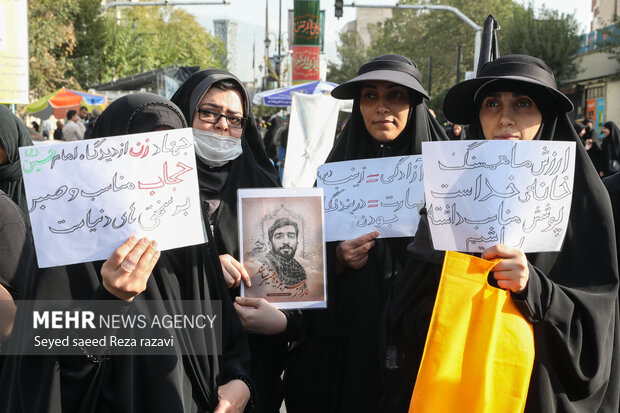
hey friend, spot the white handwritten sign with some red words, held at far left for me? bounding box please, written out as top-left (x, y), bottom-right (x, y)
top-left (19, 128), bottom-right (205, 267)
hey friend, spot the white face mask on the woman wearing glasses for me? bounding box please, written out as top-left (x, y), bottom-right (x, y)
top-left (192, 128), bottom-right (243, 166)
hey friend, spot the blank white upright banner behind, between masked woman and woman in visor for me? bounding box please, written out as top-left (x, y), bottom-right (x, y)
top-left (282, 93), bottom-right (338, 188)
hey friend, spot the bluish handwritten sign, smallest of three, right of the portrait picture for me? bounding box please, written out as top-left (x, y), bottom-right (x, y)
top-left (317, 155), bottom-right (424, 241)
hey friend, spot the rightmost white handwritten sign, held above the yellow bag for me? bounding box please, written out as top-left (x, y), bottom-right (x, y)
top-left (422, 141), bottom-right (575, 252)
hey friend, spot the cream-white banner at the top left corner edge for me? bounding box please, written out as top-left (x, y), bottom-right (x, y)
top-left (0, 0), bottom-right (30, 104)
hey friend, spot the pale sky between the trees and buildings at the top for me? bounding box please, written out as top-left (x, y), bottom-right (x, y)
top-left (183, 0), bottom-right (592, 81)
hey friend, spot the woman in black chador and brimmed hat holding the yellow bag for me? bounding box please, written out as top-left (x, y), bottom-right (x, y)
top-left (381, 55), bottom-right (620, 413)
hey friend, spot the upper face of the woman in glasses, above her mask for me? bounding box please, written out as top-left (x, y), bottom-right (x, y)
top-left (192, 88), bottom-right (243, 138)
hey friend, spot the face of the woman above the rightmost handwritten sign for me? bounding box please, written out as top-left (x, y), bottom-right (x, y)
top-left (479, 92), bottom-right (542, 141)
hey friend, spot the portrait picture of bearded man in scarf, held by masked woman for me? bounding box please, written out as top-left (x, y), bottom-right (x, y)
top-left (238, 188), bottom-right (327, 309)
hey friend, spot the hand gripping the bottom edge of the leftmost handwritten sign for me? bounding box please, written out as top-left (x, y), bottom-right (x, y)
top-left (101, 235), bottom-right (161, 301)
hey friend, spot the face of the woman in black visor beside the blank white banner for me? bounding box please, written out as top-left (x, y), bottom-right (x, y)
top-left (360, 80), bottom-right (410, 143)
